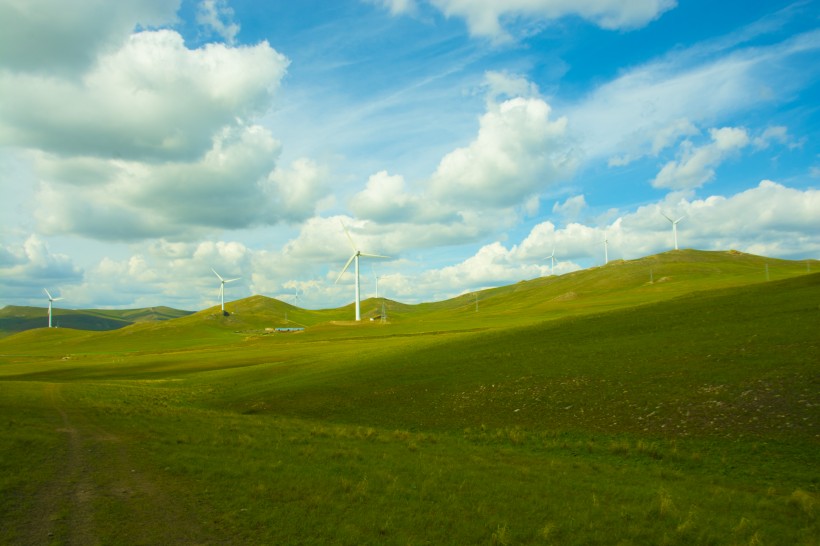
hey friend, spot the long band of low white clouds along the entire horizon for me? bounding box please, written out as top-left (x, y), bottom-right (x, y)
top-left (6, 180), bottom-right (820, 309)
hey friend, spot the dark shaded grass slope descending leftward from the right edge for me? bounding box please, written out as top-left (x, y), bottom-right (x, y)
top-left (197, 274), bottom-right (820, 439)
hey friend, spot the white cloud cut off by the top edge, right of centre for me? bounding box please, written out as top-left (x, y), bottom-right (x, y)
top-left (430, 0), bottom-right (676, 39)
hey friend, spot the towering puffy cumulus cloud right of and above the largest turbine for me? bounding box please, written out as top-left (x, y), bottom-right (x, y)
top-left (349, 73), bottom-right (578, 248)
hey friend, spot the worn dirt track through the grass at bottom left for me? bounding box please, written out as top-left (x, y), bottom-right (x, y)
top-left (17, 383), bottom-right (214, 546)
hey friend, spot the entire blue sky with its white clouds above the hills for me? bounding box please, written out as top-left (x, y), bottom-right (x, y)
top-left (0, 0), bottom-right (820, 310)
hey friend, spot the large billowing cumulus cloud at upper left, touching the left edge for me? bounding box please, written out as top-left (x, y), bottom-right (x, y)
top-left (0, 30), bottom-right (288, 161)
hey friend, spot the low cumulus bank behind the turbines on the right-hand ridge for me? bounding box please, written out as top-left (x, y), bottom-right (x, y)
top-left (511, 180), bottom-right (820, 263)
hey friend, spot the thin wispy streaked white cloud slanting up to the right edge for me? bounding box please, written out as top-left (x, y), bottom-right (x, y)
top-left (564, 32), bottom-right (820, 166)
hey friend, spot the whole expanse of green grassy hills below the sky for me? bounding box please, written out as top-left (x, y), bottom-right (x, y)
top-left (0, 251), bottom-right (820, 545)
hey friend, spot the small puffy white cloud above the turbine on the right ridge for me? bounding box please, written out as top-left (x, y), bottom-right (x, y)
top-left (652, 127), bottom-right (750, 190)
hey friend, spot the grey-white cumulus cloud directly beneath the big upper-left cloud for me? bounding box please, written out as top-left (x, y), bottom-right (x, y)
top-left (35, 126), bottom-right (325, 240)
